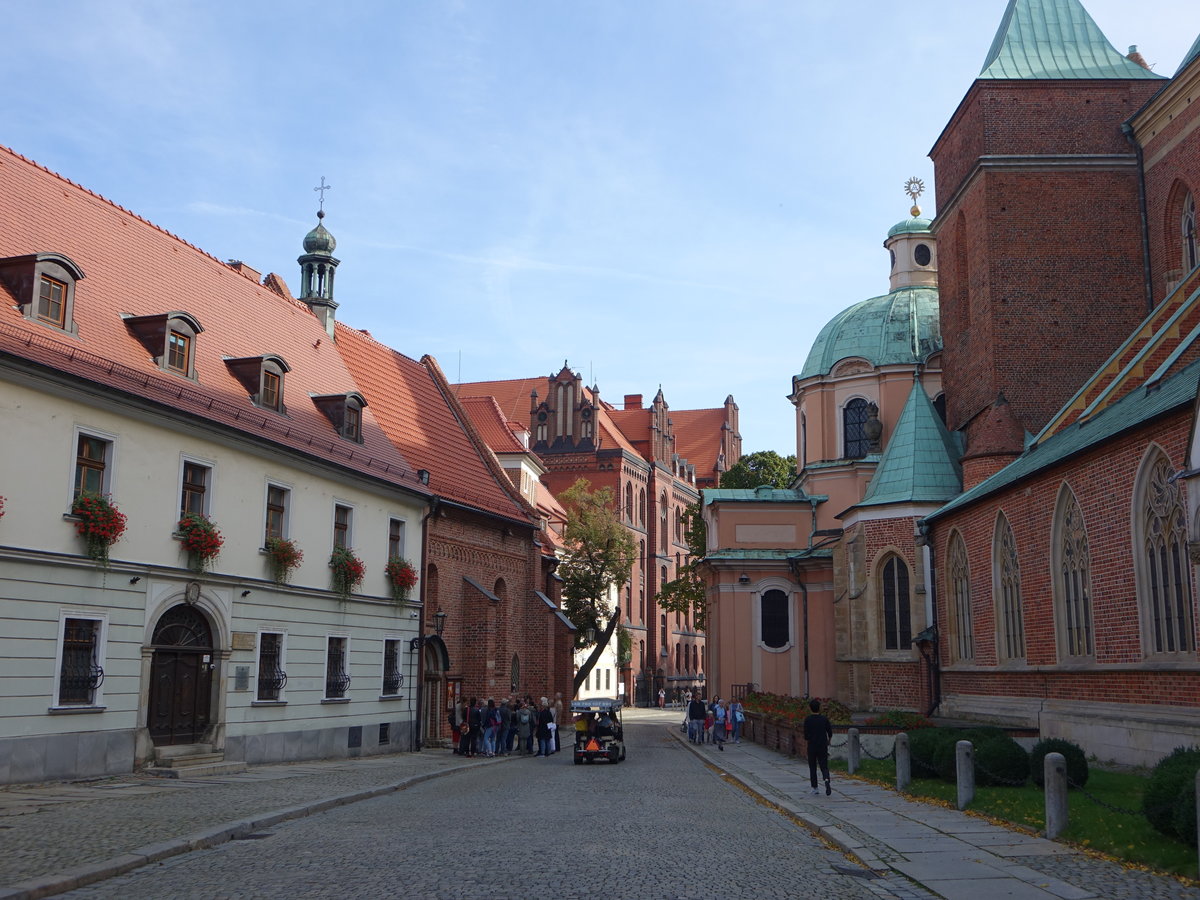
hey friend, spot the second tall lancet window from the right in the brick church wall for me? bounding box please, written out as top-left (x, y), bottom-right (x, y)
top-left (1054, 487), bottom-right (1094, 658)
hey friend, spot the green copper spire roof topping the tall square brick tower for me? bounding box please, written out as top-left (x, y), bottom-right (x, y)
top-left (979, 0), bottom-right (1162, 79)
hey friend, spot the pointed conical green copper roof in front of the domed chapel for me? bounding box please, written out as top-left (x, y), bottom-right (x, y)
top-left (858, 379), bottom-right (962, 506)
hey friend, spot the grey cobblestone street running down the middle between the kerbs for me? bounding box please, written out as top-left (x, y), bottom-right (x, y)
top-left (54, 724), bottom-right (934, 900)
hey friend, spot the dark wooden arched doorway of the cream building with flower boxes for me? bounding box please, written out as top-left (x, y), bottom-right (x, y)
top-left (146, 604), bottom-right (215, 745)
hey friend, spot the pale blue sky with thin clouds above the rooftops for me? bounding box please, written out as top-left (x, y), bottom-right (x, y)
top-left (0, 0), bottom-right (1200, 455)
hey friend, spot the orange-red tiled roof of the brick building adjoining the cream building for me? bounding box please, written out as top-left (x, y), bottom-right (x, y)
top-left (336, 322), bottom-right (532, 524)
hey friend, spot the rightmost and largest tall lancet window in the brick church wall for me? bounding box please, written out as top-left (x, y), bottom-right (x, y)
top-left (1136, 452), bottom-right (1195, 654)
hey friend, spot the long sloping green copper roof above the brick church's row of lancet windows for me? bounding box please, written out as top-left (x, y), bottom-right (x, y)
top-left (928, 352), bottom-right (1200, 518)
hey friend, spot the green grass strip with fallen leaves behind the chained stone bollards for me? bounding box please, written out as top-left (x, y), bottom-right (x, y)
top-left (829, 758), bottom-right (1198, 878)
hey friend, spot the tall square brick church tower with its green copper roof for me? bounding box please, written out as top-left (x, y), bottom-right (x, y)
top-left (930, 0), bottom-right (1163, 443)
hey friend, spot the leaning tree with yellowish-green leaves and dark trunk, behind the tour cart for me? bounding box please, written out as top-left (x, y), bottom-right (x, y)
top-left (558, 478), bottom-right (637, 694)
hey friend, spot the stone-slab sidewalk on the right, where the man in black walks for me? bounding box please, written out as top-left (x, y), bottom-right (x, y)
top-left (668, 714), bottom-right (1200, 900)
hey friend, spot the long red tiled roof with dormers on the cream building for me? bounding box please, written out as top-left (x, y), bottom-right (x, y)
top-left (0, 148), bottom-right (427, 493)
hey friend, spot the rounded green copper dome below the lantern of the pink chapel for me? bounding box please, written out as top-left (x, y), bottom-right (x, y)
top-left (797, 287), bottom-right (942, 379)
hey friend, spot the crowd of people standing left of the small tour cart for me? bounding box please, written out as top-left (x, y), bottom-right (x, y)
top-left (449, 694), bottom-right (563, 756)
